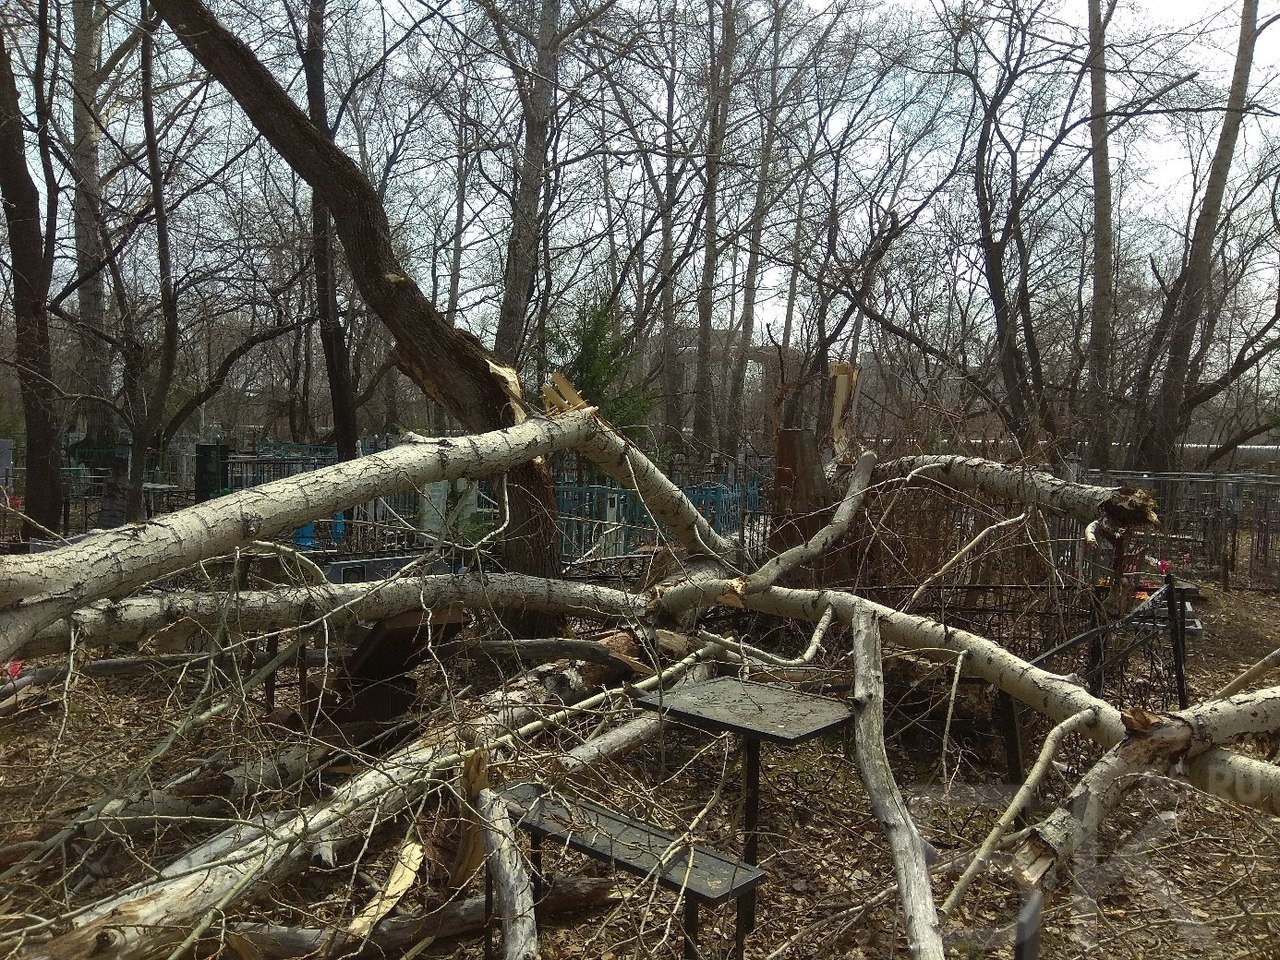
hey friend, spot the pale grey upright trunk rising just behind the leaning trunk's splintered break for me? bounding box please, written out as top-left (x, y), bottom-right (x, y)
top-left (493, 0), bottom-right (561, 366)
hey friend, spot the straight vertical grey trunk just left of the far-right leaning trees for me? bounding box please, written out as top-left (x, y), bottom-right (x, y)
top-left (1085, 0), bottom-right (1115, 470)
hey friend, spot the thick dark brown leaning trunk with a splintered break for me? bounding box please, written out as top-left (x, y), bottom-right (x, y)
top-left (155, 0), bottom-right (559, 631)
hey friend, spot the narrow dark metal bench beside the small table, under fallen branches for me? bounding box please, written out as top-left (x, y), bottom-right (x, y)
top-left (485, 781), bottom-right (764, 960)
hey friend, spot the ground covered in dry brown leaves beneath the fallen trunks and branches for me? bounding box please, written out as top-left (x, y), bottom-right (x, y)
top-left (0, 586), bottom-right (1280, 960)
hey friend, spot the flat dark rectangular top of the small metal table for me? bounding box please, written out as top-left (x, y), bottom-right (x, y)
top-left (635, 677), bottom-right (854, 744)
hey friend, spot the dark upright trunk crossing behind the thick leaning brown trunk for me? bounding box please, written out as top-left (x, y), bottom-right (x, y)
top-left (302, 0), bottom-right (360, 460)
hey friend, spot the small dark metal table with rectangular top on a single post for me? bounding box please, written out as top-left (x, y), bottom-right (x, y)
top-left (635, 677), bottom-right (854, 942)
